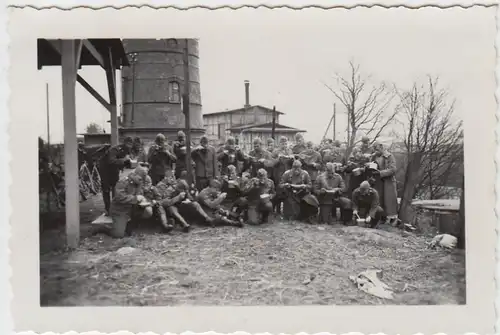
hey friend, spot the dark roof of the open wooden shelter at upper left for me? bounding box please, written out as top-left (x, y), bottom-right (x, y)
top-left (37, 38), bottom-right (130, 69)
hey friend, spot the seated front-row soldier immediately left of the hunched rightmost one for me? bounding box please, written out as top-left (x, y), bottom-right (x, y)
top-left (314, 163), bottom-right (352, 224)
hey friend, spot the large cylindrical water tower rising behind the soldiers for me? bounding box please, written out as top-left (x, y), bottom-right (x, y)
top-left (120, 39), bottom-right (205, 145)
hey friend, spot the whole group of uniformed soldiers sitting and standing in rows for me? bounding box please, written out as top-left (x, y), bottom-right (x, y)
top-left (93, 131), bottom-right (398, 237)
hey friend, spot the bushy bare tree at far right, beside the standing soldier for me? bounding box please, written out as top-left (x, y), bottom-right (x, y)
top-left (397, 77), bottom-right (463, 222)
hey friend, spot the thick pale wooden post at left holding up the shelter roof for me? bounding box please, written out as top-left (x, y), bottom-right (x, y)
top-left (61, 40), bottom-right (80, 248)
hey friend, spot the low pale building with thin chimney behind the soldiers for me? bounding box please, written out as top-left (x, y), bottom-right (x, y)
top-left (203, 81), bottom-right (305, 151)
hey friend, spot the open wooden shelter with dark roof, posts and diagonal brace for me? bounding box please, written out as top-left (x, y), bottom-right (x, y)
top-left (37, 39), bottom-right (129, 248)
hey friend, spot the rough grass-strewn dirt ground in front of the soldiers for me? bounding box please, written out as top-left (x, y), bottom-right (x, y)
top-left (40, 194), bottom-right (465, 306)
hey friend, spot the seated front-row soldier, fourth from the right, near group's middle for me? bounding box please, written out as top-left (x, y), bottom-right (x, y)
top-left (246, 169), bottom-right (276, 225)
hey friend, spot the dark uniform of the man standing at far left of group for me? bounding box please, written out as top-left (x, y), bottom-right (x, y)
top-left (99, 144), bottom-right (130, 212)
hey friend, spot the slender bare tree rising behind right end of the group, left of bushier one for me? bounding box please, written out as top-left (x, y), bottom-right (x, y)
top-left (324, 61), bottom-right (397, 155)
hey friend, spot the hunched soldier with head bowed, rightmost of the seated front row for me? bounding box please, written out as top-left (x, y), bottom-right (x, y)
top-left (352, 180), bottom-right (386, 228)
